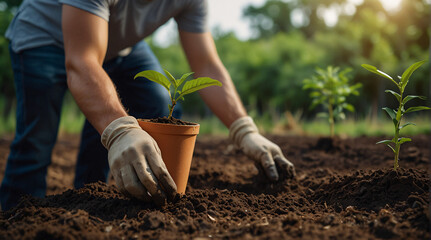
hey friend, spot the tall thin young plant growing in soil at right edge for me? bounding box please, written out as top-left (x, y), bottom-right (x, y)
top-left (361, 60), bottom-right (431, 170)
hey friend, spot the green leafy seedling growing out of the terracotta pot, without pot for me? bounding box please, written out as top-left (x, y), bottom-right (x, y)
top-left (135, 69), bottom-right (222, 120)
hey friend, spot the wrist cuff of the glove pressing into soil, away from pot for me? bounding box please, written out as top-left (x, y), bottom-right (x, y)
top-left (229, 116), bottom-right (259, 148)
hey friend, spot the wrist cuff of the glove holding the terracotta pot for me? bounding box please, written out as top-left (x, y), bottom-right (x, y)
top-left (100, 116), bottom-right (140, 150)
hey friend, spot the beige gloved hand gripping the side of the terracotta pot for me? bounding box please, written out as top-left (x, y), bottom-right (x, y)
top-left (101, 116), bottom-right (177, 205)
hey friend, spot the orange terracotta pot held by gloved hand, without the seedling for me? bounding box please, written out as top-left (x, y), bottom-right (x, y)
top-left (138, 119), bottom-right (199, 194)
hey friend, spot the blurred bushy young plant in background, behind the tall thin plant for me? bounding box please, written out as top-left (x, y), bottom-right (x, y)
top-left (303, 66), bottom-right (362, 137)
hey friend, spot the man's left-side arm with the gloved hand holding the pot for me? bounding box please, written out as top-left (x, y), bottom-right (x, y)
top-left (62, 5), bottom-right (176, 205)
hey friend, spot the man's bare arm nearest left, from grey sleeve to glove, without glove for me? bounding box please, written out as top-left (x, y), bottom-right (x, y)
top-left (62, 5), bottom-right (127, 134)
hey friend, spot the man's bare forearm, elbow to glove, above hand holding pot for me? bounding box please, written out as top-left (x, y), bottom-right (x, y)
top-left (67, 61), bottom-right (127, 134)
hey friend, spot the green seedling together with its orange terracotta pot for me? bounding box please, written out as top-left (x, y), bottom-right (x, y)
top-left (135, 70), bottom-right (222, 194)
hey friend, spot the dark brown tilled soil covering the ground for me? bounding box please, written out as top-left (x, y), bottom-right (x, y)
top-left (0, 136), bottom-right (431, 239)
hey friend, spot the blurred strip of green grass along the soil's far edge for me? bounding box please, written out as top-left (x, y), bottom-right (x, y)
top-left (0, 101), bottom-right (431, 137)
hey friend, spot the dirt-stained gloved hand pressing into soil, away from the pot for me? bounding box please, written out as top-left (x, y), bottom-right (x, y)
top-left (229, 117), bottom-right (295, 181)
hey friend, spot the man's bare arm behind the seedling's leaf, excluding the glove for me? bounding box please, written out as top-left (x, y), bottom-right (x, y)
top-left (180, 31), bottom-right (247, 128)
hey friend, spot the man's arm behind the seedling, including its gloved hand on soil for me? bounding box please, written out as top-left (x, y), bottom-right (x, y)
top-left (180, 31), bottom-right (295, 181)
